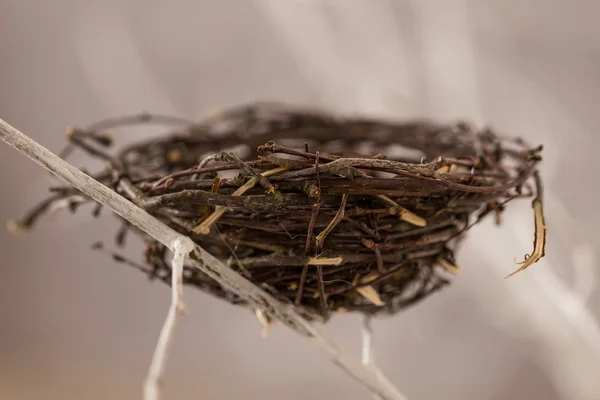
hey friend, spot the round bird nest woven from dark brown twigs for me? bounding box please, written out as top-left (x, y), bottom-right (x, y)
top-left (13, 104), bottom-right (545, 319)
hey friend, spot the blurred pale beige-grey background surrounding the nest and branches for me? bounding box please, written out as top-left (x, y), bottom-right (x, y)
top-left (0, 0), bottom-right (600, 400)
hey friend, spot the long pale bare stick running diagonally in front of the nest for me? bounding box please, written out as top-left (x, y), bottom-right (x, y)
top-left (0, 119), bottom-right (405, 400)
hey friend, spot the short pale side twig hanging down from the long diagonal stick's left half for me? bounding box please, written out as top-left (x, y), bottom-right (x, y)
top-left (144, 238), bottom-right (194, 400)
